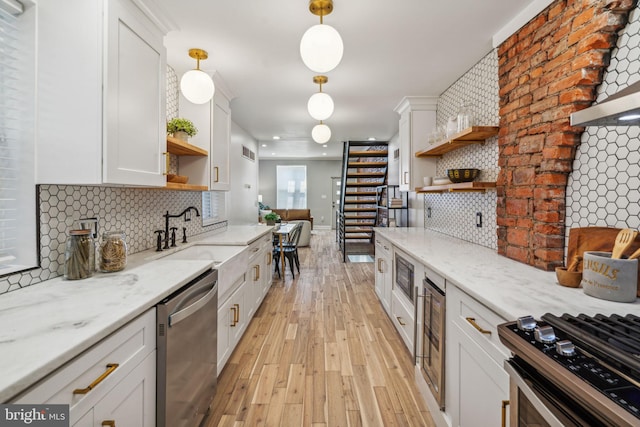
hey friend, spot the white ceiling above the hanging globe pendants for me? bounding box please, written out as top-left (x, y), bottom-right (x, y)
top-left (156, 0), bottom-right (534, 159)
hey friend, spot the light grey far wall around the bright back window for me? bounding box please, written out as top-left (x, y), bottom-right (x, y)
top-left (258, 159), bottom-right (342, 228)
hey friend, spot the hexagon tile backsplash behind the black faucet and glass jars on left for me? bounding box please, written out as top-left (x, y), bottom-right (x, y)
top-left (0, 185), bottom-right (227, 294)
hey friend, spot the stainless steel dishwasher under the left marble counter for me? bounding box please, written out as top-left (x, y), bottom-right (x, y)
top-left (156, 270), bottom-right (218, 427)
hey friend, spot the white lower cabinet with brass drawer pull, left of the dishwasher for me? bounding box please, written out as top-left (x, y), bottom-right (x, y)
top-left (13, 308), bottom-right (156, 427)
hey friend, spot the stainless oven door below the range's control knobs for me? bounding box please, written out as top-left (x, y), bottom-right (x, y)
top-left (504, 358), bottom-right (614, 427)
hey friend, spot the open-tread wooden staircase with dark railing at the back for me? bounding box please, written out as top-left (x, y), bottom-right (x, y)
top-left (336, 141), bottom-right (388, 261)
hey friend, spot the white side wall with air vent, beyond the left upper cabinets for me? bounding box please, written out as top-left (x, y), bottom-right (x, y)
top-left (227, 122), bottom-right (258, 225)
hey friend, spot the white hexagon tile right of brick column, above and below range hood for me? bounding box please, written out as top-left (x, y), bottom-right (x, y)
top-left (565, 6), bottom-right (640, 248)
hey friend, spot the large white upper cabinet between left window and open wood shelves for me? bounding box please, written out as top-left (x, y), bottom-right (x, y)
top-left (36, 0), bottom-right (166, 186)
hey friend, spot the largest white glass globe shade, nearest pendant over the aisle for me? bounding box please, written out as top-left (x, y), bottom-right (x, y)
top-left (300, 24), bottom-right (344, 73)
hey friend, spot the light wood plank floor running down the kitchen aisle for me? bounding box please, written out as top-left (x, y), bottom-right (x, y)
top-left (207, 230), bottom-right (434, 427)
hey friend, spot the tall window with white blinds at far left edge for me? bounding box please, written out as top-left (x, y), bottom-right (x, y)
top-left (0, 0), bottom-right (38, 276)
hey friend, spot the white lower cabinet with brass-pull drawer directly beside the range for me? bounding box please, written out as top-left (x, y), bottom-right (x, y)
top-left (445, 285), bottom-right (509, 427)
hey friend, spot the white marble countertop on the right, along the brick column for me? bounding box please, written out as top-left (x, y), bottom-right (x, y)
top-left (375, 228), bottom-right (640, 320)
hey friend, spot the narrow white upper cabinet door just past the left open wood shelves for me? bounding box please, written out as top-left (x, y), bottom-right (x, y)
top-left (209, 91), bottom-right (231, 191)
